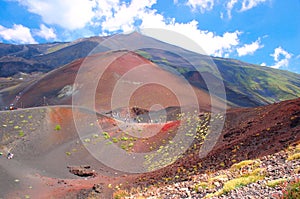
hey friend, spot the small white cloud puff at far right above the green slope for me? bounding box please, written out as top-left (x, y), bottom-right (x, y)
top-left (271, 46), bottom-right (292, 69)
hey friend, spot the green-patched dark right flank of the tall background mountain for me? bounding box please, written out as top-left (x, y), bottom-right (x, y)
top-left (138, 49), bottom-right (300, 107)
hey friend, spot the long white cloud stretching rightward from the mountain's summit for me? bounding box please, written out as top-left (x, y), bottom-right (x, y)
top-left (141, 11), bottom-right (241, 56)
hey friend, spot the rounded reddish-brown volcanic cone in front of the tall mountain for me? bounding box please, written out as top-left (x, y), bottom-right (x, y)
top-left (14, 51), bottom-right (223, 112)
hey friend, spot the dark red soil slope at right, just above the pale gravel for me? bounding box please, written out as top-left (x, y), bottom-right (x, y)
top-left (136, 98), bottom-right (300, 187)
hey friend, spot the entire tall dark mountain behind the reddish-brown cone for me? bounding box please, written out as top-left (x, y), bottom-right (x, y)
top-left (0, 32), bottom-right (300, 107)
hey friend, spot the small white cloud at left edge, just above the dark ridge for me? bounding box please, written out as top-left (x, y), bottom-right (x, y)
top-left (0, 24), bottom-right (36, 44)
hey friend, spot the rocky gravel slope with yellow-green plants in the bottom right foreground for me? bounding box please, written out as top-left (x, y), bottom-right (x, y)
top-left (121, 144), bottom-right (300, 199)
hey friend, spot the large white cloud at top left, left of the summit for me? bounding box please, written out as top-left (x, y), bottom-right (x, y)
top-left (18, 0), bottom-right (96, 30)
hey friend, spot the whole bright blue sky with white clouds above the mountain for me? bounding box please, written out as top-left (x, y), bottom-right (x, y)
top-left (0, 0), bottom-right (300, 73)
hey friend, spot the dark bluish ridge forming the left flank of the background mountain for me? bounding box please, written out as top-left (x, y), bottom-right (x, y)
top-left (0, 38), bottom-right (108, 77)
